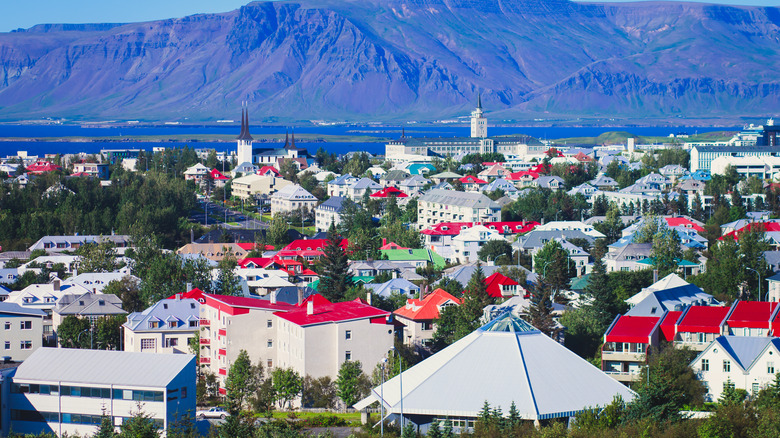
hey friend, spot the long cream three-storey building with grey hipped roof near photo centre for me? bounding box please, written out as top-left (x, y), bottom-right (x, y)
top-left (417, 190), bottom-right (501, 228)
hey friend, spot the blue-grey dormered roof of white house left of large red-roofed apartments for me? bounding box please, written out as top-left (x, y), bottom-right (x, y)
top-left (124, 298), bottom-right (200, 332)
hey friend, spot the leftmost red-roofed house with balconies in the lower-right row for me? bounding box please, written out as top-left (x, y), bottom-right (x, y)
top-left (601, 315), bottom-right (661, 382)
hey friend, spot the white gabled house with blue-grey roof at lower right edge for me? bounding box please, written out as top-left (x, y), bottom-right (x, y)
top-left (691, 336), bottom-right (780, 402)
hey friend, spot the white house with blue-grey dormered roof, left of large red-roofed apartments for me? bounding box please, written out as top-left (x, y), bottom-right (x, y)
top-left (122, 294), bottom-right (201, 353)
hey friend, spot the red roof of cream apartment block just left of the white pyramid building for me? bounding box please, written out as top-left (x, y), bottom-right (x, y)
top-left (275, 294), bottom-right (390, 326)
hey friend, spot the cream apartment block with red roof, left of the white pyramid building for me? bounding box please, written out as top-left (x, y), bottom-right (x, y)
top-left (276, 294), bottom-right (396, 380)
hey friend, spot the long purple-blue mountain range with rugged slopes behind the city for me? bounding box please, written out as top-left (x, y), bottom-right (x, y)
top-left (0, 0), bottom-right (780, 122)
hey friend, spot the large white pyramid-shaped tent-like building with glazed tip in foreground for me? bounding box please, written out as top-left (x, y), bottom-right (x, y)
top-left (354, 313), bottom-right (635, 430)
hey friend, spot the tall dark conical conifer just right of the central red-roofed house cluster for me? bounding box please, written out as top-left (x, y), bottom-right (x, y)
top-left (317, 224), bottom-right (352, 302)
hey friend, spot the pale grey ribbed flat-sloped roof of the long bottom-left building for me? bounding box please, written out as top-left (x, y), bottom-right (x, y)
top-left (14, 347), bottom-right (195, 388)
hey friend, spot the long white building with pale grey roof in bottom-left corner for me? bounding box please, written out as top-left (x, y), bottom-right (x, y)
top-left (4, 348), bottom-right (196, 436)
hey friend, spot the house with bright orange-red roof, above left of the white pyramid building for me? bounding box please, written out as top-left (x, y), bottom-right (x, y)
top-left (393, 289), bottom-right (463, 346)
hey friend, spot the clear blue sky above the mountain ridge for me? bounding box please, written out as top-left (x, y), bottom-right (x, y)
top-left (0, 0), bottom-right (780, 32)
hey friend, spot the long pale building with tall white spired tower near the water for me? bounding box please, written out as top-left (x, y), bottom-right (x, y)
top-left (385, 96), bottom-right (547, 162)
